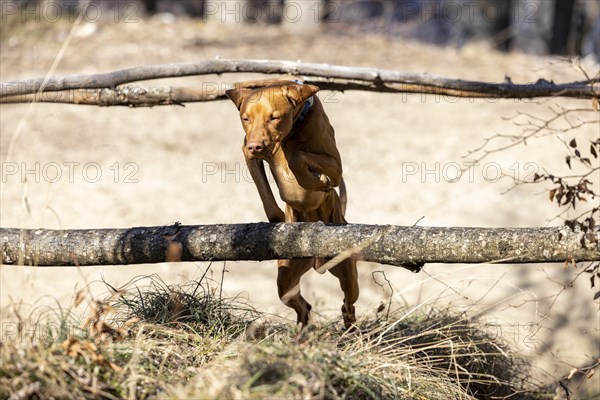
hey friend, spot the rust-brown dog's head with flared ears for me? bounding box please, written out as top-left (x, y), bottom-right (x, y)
top-left (226, 81), bottom-right (319, 159)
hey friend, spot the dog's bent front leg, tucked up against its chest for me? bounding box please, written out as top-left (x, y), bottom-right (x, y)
top-left (290, 151), bottom-right (342, 191)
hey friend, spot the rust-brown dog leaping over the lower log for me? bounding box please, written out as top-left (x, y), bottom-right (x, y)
top-left (227, 80), bottom-right (358, 328)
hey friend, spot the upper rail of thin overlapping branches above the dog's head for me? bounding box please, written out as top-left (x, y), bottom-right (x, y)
top-left (0, 59), bottom-right (600, 107)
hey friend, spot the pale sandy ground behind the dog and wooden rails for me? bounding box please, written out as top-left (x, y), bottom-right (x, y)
top-left (0, 12), bottom-right (600, 394)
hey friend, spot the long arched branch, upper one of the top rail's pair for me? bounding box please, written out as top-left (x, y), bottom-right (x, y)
top-left (0, 59), bottom-right (600, 105)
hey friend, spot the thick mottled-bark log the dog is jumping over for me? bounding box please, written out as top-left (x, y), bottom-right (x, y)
top-left (0, 223), bottom-right (600, 271)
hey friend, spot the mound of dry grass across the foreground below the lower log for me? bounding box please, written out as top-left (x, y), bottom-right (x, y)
top-left (0, 276), bottom-right (551, 399)
